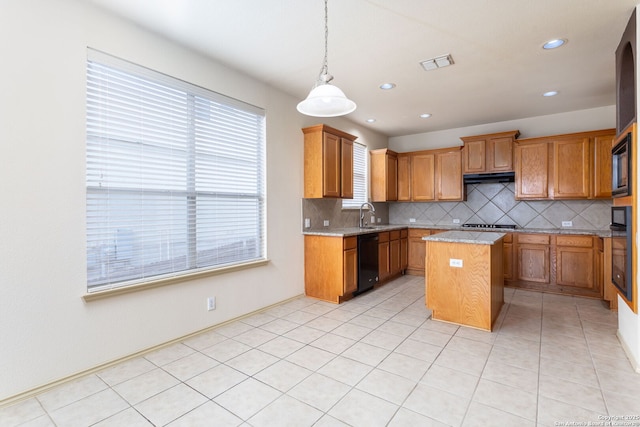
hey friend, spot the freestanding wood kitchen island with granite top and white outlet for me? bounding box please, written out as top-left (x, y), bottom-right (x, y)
top-left (423, 231), bottom-right (505, 331)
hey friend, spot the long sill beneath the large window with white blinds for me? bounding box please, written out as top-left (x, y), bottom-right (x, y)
top-left (82, 259), bottom-right (269, 302)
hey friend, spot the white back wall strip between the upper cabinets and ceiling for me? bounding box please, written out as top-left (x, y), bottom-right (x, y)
top-left (389, 105), bottom-right (616, 153)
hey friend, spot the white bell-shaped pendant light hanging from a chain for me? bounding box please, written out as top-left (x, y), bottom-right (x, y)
top-left (297, 0), bottom-right (356, 117)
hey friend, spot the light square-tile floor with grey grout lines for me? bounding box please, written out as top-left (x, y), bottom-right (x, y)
top-left (0, 276), bottom-right (640, 427)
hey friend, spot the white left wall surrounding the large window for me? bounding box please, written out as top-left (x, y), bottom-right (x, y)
top-left (0, 0), bottom-right (387, 402)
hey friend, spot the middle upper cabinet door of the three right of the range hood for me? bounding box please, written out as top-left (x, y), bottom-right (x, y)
top-left (553, 138), bottom-right (591, 199)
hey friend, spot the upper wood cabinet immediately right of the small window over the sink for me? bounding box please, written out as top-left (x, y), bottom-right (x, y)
top-left (369, 148), bottom-right (398, 202)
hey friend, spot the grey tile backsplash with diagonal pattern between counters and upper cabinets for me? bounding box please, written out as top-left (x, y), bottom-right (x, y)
top-left (302, 183), bottom-right (612, 230)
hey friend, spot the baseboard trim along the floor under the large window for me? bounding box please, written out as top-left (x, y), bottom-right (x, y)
top-left (0, 294), bottom-right (304, 408)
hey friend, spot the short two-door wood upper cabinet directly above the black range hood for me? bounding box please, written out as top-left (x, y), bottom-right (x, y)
top-left (460, 130), bottom-right (520, 173)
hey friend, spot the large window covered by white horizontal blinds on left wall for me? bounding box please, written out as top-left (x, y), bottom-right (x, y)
top-left (86, 51), bottom-right (265, 291)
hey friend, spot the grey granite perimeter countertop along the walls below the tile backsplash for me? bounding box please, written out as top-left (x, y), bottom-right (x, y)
top-left (302, 223), bottom-right (614, 237)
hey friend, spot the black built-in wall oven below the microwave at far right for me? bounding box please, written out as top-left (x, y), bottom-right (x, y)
top-left (611, 206), bottom-right (633, 302)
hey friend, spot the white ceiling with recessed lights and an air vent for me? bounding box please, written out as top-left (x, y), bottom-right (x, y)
top-left (89, 0), bottom-right (638, 136)
